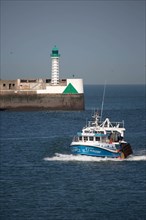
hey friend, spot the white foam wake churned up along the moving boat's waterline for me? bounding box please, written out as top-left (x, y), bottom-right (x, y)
top-left (44, 153), bottom-right (146, 162)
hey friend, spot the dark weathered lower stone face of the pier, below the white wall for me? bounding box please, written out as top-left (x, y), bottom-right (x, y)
top-left (0, 91), bottom-right (84, 111)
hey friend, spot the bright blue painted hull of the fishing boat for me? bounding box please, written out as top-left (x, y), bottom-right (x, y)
top-left (70, 145), bottom-right (121, 158)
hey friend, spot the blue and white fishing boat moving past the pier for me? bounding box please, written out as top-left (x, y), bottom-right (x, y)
top-left (70, 112), bottom-right (133, 159)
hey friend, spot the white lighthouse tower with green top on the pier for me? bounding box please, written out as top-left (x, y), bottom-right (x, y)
top-left (51, 46), bottom-right (60, 85)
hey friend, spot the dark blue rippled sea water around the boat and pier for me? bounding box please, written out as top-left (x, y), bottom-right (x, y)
top-left (0, 86), bottom-right (146, 220)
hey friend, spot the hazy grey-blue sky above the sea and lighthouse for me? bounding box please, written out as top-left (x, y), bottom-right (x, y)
top-left (1, 0), bottom-right (146, 84)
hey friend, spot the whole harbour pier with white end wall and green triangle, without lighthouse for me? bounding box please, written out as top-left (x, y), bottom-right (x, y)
top-left (0, 79), bottom-right (84, 111)
